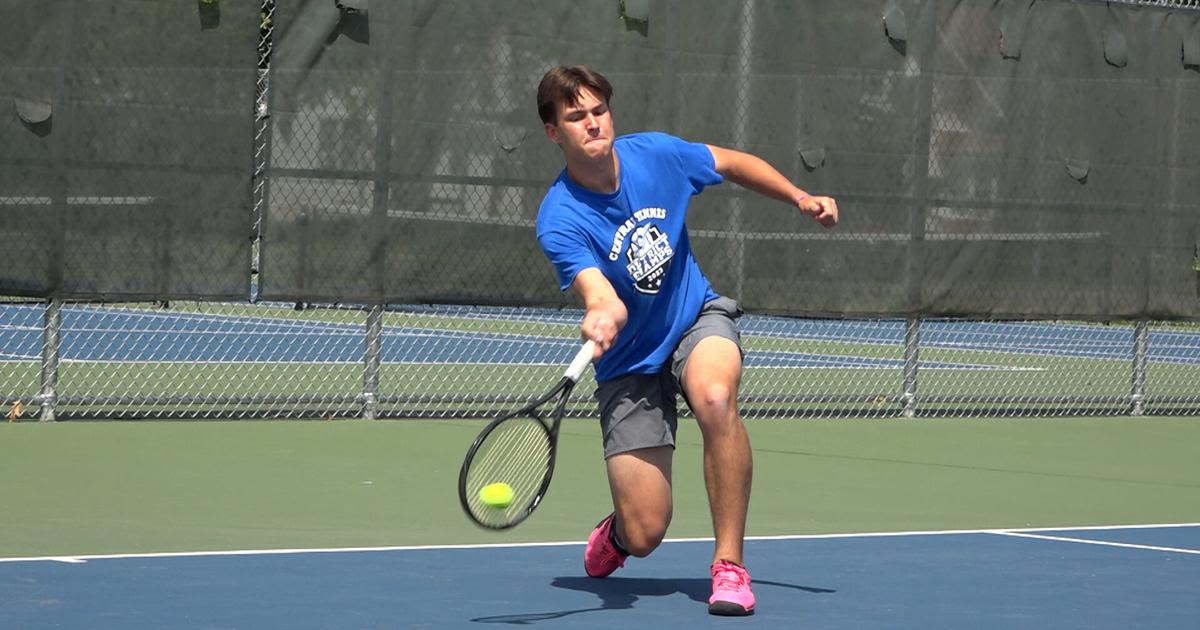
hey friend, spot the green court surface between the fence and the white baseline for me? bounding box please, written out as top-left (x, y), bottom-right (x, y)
top-left (0, 418), bottom-right (1200, 558)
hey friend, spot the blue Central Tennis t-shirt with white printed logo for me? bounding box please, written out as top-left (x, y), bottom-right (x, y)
top-left (538, 133), bottom-right (722, 380)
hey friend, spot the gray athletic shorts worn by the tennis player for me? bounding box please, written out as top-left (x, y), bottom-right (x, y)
top-left (596, 298), bottom-right (742, 458)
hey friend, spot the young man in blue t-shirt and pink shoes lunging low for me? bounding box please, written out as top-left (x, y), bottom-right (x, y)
top-left (538, 66), bottom-right (838, 614)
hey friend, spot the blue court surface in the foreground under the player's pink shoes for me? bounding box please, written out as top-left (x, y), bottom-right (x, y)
top-left (0, 523), bottom-right (1200, 630)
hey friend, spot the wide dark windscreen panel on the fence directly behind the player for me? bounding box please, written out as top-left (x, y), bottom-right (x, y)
top-left (262, 0), bottom-right (1200, 319)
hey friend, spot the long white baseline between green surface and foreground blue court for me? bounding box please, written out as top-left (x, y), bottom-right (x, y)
top-left (0, 523), bottom-right (1200, 564)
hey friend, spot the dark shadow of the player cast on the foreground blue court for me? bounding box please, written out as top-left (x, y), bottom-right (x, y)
top-left (472, 576), bottom-right (836, 625)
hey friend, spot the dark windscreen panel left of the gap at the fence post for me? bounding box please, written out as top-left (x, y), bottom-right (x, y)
top-left (0, 0), bottom-right (258, 300)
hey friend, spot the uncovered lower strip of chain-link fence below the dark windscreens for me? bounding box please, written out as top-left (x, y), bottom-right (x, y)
top-left (0, 300), bottom-right (1200, 420)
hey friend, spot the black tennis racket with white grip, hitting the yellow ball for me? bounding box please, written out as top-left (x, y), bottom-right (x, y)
top-left (458, 341), bottom-right (595, 529)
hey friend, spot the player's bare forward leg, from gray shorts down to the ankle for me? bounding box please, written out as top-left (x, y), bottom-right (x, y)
top-left (683, 337), bottom-right (754, 564)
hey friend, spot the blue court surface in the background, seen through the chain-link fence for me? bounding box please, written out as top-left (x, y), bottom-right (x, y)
top-left (0, 305), bottom-right (1200, 370)
